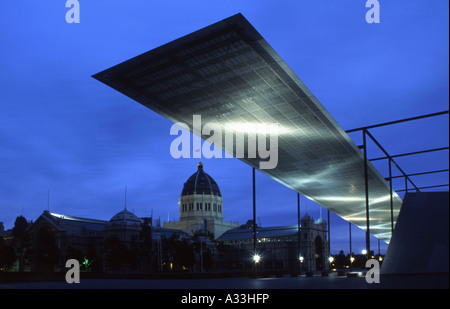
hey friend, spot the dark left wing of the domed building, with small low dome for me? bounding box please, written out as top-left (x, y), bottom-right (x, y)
top-left (27, 208), bottom-right (189, 272)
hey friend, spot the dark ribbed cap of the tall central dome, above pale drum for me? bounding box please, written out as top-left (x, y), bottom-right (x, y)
top-left (181, 162), bottom-right (222, 196)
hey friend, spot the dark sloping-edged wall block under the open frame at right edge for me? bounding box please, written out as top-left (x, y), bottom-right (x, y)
top-left (381, 192), bottom-right (449, 274)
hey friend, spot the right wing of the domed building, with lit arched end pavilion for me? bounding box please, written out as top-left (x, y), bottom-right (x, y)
top-left (217, 214), bottom-right (329, 272)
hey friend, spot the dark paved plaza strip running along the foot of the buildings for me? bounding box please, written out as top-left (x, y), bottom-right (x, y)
top-left (0, 274), bottom-right (449, 290)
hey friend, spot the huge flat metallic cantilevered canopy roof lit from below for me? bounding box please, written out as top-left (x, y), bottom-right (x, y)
top-left (94, 14), bottom-right (402, 242)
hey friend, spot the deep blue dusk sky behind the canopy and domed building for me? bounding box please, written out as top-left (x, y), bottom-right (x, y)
top-left (0, 0), bottom-right (449, 253)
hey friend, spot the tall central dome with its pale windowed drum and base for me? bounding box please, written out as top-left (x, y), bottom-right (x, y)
top-left (163, 162), bottom-right (239, 238)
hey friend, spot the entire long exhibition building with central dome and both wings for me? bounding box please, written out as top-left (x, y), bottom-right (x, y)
top-left (5, 162), bottom-right (329, 272)
